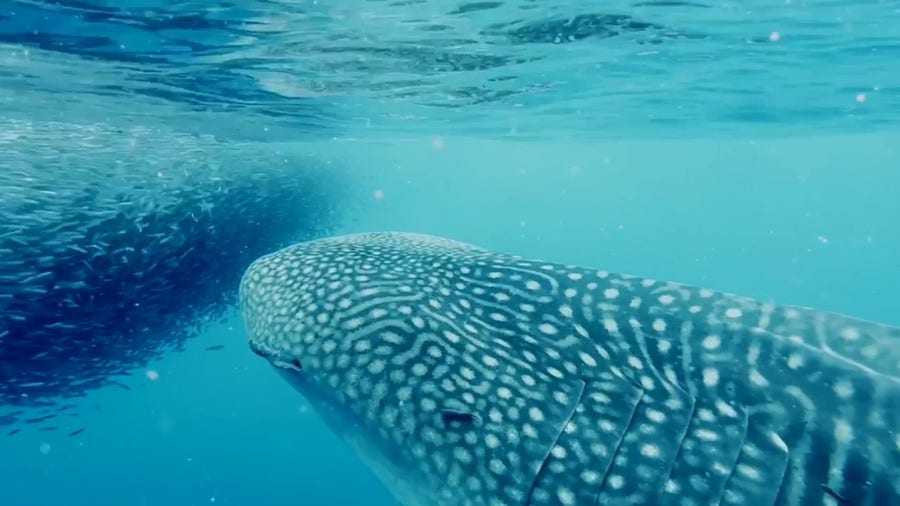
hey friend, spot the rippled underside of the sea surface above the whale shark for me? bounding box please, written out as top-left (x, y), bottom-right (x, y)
top-left (0, 0), bottom-right (900, 139)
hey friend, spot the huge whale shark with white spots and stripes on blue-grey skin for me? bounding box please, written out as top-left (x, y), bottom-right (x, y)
top-left (241, 233), bottom-right (900, 506)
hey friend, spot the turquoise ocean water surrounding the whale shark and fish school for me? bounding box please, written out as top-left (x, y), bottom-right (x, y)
top-left (0, 0), bottom-right (900, 506)
